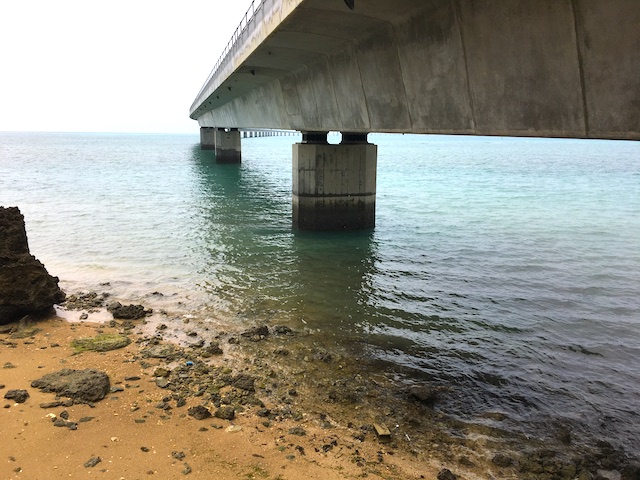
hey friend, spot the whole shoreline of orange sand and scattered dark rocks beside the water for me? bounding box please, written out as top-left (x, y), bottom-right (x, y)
top-left (0, 296), bottom-right (640, 480)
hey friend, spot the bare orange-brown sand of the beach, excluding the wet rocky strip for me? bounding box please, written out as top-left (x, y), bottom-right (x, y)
top-left (0, 317), bottom-right (450, 479)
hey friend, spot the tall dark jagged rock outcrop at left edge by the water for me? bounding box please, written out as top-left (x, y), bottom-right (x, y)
top-left (0, 207), bottom-right (65, 325)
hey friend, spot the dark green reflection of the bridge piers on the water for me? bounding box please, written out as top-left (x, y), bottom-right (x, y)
top-left (192, 148), bottom-right (376, 334)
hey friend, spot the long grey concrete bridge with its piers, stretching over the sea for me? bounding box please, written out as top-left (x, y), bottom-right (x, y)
top-left (190, 0), bottom-right (640, 229)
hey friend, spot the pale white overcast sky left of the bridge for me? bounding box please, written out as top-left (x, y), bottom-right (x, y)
top-left (0, 0), bottom-right (251, 133)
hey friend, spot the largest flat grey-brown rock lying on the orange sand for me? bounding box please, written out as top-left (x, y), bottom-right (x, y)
top-left (31, 368), bottom-right (111, 403)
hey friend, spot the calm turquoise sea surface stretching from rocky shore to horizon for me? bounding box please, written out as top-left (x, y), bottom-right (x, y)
top-left (0, 131), bottom-right (640, 451)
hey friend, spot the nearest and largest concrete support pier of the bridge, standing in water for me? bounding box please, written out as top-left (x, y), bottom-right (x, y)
top-left (293, 132), bottom-right (378, 230)
